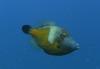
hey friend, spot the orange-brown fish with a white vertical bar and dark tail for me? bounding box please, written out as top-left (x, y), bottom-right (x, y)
top-left (22, 21), bottom-right (80, 56)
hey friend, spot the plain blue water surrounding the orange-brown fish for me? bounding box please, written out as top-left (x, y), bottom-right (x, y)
top-left (0, 0), bottom-right (100, 69)
